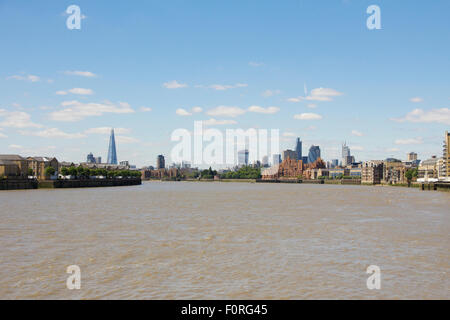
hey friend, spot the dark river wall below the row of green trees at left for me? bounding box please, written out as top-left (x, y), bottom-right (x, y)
top-left (38, 178), bottom-right (142, 189)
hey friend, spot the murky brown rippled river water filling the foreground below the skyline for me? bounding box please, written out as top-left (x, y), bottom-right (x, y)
top-left (0, 182), bottom-right (450, 299)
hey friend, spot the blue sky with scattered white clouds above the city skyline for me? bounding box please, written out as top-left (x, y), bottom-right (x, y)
top-left (0, 0), bottom-right (450, 166)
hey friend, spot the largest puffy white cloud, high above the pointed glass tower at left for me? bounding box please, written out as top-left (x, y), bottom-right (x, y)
top-left (50, 100), bottom-right (134, 122)
